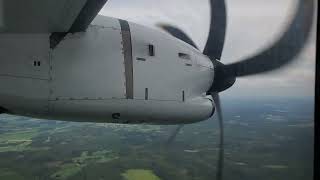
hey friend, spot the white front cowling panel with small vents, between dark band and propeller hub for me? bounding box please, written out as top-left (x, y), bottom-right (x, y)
top-left (130, 23), bottom-right (213, 102)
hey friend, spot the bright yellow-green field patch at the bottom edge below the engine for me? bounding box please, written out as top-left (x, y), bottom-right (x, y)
top-left (122, 169), bottom-right (161, 180)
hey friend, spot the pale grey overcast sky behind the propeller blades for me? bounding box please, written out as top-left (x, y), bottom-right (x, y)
top-left (100, 0), bottom-right (316, 96)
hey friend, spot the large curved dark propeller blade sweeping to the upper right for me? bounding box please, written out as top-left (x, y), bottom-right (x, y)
top-left (210, 0), bottom-right (314, 77)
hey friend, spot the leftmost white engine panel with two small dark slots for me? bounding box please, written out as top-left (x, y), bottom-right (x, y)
top-left (0, 34), bottom-right (49, 115)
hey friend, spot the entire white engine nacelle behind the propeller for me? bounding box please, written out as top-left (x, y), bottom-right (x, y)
top-left (0, 16), bottom-right (214, 124)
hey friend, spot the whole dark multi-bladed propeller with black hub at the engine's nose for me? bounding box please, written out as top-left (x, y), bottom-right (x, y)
top-left (162, 0), bottom-right (315, 180)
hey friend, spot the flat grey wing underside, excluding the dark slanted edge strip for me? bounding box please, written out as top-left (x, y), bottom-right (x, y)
top-left (0, 0), bottom-right (86, 33)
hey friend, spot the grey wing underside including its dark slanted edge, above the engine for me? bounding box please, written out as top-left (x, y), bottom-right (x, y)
top-left (0, 0), bottom-right (107, 33)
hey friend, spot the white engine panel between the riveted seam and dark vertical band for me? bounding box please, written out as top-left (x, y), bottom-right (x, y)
top-left (51, 19), bottom-right (125, 100)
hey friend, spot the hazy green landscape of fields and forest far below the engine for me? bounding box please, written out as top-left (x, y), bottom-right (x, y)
top-left (0, 98), bottom-right (313, 180)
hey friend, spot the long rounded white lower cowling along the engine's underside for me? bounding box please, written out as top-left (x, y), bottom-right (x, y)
top-left (50, 98), bottom-right (214, 124)
